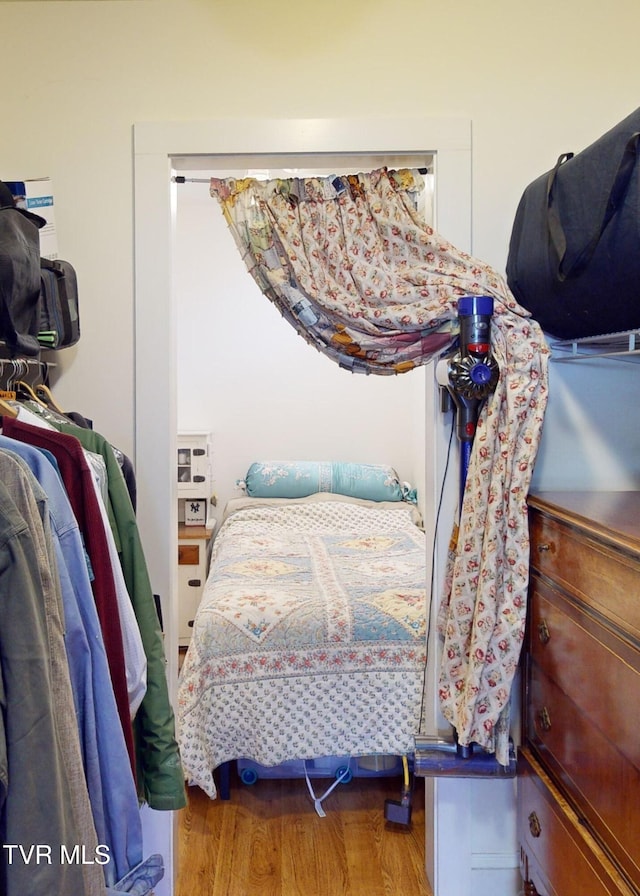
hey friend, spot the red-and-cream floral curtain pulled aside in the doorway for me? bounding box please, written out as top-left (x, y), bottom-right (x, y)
top-left (211, 169), bottom-right (548, 765)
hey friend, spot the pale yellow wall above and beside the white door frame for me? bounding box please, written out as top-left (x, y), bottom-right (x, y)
top-left (0, 0), bottom-right (640, 451)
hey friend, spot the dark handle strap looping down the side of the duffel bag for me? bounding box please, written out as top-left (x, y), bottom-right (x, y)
top-left (547, 131), bottom-right (640, 282)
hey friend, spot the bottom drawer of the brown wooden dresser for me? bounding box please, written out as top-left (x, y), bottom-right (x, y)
top-left (518, 750), bottom-right (633, 896)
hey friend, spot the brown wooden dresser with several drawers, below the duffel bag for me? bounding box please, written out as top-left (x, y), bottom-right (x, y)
top-left (518, 492), bottom-right (640, 896)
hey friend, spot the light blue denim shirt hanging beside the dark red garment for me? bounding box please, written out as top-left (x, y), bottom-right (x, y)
top-left (0, 436), bottom-right (142, 886)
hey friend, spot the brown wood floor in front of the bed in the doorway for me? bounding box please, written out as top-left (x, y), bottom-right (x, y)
top-left (176, 775), bottom-right (431, 896)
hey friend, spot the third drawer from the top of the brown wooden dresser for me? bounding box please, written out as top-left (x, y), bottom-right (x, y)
top-left (527, 662), bottom-right (640, 887)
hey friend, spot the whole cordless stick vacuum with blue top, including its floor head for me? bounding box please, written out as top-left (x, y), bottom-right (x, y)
top-left (414, 296), bottom-right (515, 778)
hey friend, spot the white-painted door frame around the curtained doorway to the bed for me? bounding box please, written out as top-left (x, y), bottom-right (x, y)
top-left (133, 118), bottom-right (472, 896)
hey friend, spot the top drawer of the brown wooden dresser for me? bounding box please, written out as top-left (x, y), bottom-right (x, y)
top-left (529, 509), bottom-right (640, 643)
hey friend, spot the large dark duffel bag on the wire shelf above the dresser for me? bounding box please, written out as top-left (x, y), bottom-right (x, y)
top-left (506, 109), bottom-right (640, 339)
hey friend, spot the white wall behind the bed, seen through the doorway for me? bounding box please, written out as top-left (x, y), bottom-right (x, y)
top-left (175, 172), bottom-right (426, 519)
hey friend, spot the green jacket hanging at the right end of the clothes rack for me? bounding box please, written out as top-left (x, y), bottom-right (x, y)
top-left (55, 420), bottom-right (186, 810)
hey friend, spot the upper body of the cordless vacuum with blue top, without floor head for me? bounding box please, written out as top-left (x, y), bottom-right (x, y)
top-left (436, 296), bottom-right (500, 508)
